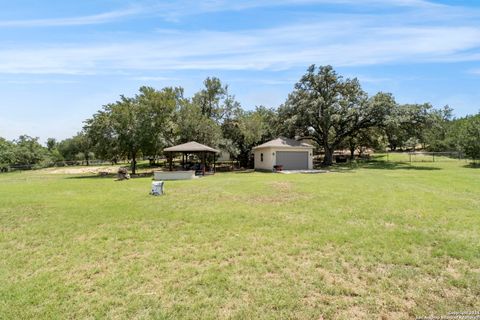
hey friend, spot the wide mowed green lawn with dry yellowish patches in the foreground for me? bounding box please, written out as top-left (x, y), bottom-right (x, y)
top-left (0, 161), bottom-right (480, 319)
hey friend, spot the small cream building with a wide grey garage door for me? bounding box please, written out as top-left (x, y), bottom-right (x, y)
top-left (253, 137), bottom-right (313, 171)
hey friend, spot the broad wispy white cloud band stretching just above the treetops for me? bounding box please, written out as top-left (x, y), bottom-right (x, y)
top-left (0, 18), bottom-right (480, 75)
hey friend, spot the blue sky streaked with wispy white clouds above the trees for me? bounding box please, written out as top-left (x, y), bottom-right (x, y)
top-left (0, 0), bottom-right (480, 141)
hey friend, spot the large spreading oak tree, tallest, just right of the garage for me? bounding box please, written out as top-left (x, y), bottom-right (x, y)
top-left (279, 65), bottom-right (386, 165)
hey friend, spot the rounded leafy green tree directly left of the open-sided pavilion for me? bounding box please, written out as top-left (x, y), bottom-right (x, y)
top-left (85, 87), bottom-right (183, 174)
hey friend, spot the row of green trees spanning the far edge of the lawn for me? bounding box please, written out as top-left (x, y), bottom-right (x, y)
top-left (0, 65), bottom-right (480, 173)
